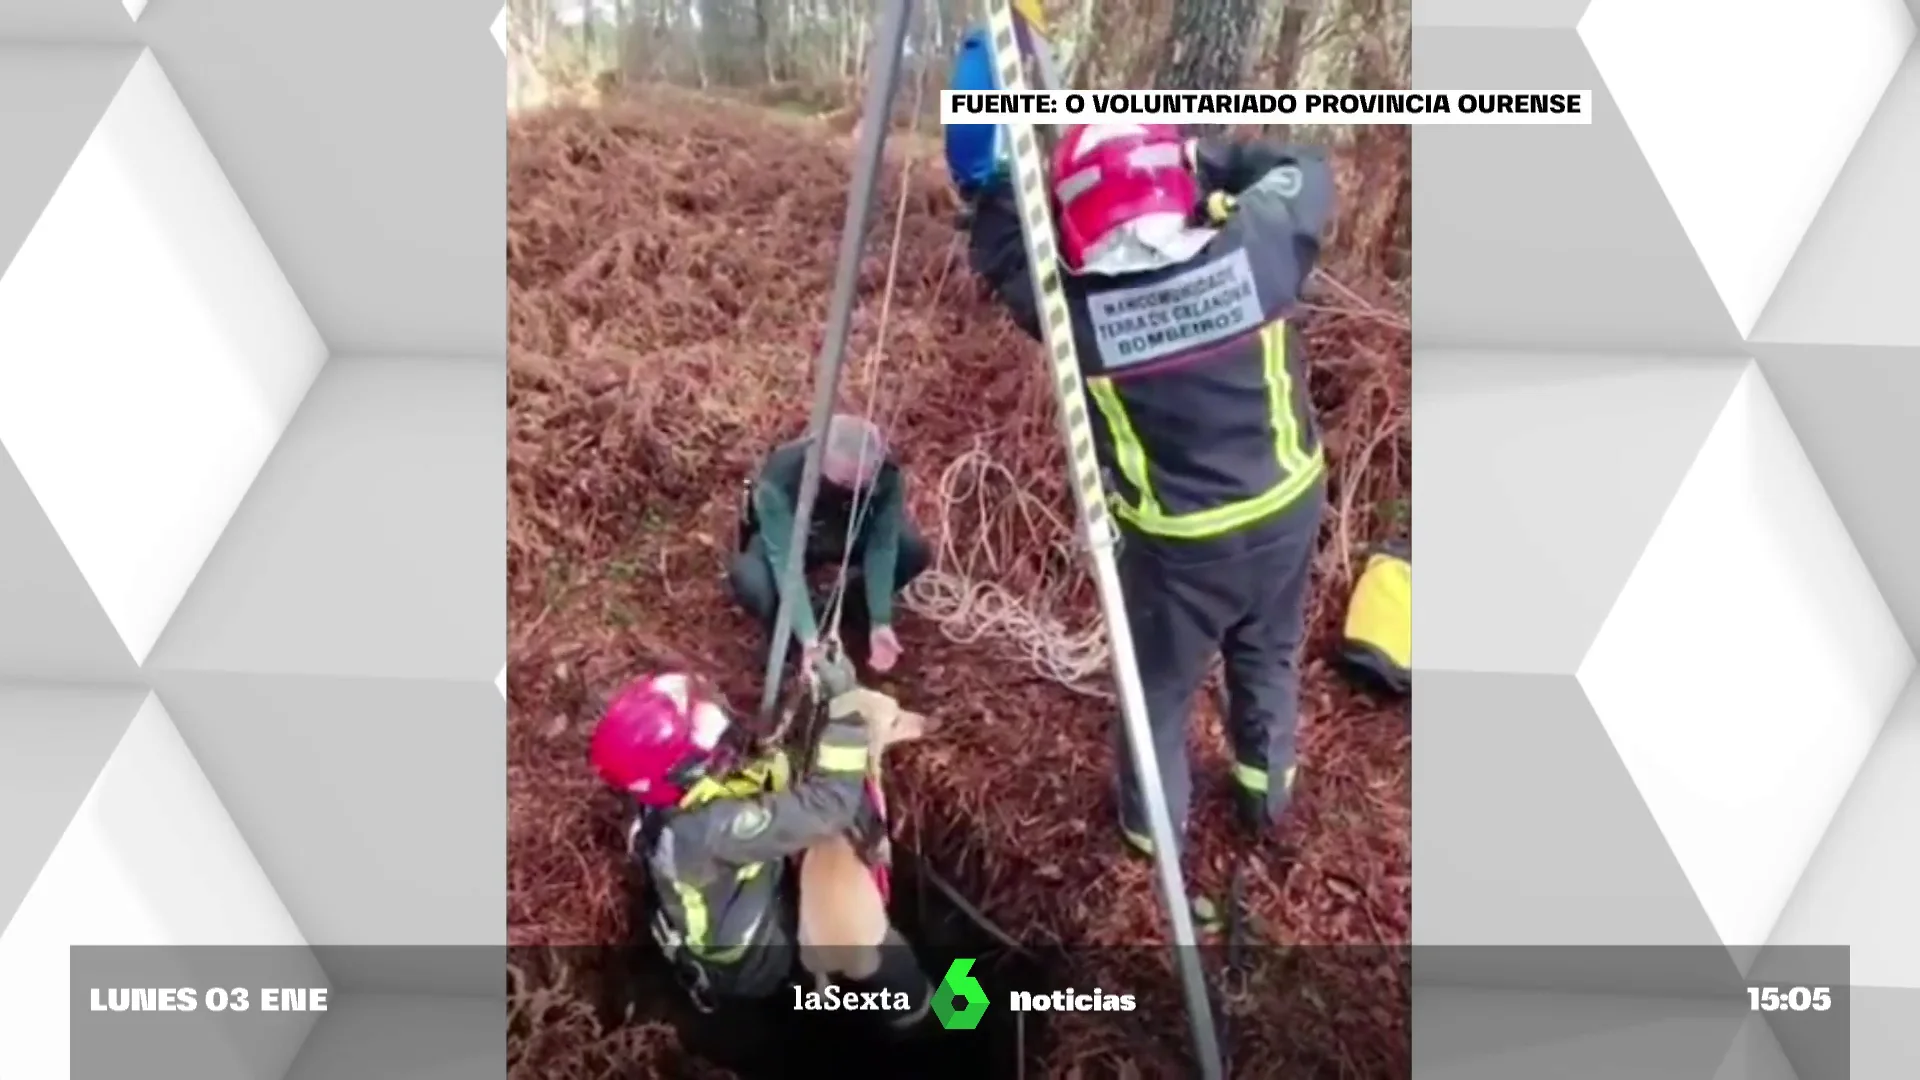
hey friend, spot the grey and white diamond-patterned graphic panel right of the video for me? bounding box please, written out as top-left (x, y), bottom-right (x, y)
top-left (1411, 0), bottom-right (1920, 1080)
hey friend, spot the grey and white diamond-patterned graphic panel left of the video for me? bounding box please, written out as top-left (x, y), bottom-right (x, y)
top-left (0, 0), bottom-right (505, 1080)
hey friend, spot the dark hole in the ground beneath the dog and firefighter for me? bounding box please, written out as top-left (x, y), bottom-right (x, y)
top-left (601, 847), bottom-right (1064, 1080)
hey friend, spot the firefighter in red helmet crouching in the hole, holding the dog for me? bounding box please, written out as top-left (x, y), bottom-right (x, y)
top-left (591, 675), bottom-right (933, 1032)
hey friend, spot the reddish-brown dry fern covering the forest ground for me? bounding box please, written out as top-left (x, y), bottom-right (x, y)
top-left (509, 92), bottom-right (1411, 1078)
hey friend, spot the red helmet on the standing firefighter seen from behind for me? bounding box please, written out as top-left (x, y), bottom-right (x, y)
top-left (1054, 123), bottom-right (1200, 271)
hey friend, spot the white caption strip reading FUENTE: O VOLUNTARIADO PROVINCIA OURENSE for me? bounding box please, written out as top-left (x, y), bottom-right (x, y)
top-left (941, 90), bottom-right (1594, 127)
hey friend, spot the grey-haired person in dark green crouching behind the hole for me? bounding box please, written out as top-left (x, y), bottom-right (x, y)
top-left (728, 413), bottom-right (929, 673)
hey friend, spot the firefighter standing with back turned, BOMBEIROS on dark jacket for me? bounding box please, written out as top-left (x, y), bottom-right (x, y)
top-left (947, 113), bottom-right (1332, 853)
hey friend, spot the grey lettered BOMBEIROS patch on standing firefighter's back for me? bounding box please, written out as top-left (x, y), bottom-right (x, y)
top-left (1087, 248), bottom-right (1263, 371)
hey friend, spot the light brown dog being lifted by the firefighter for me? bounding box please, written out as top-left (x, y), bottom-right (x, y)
top-left (799, 688), bottom-right (933, 986)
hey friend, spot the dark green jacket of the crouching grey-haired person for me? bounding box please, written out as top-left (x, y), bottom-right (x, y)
top-left (753, 438), bottom-right (906, 640)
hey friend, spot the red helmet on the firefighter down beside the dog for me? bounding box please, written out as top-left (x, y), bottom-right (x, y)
top-left (591, 675), bottom-right (730, 807)
